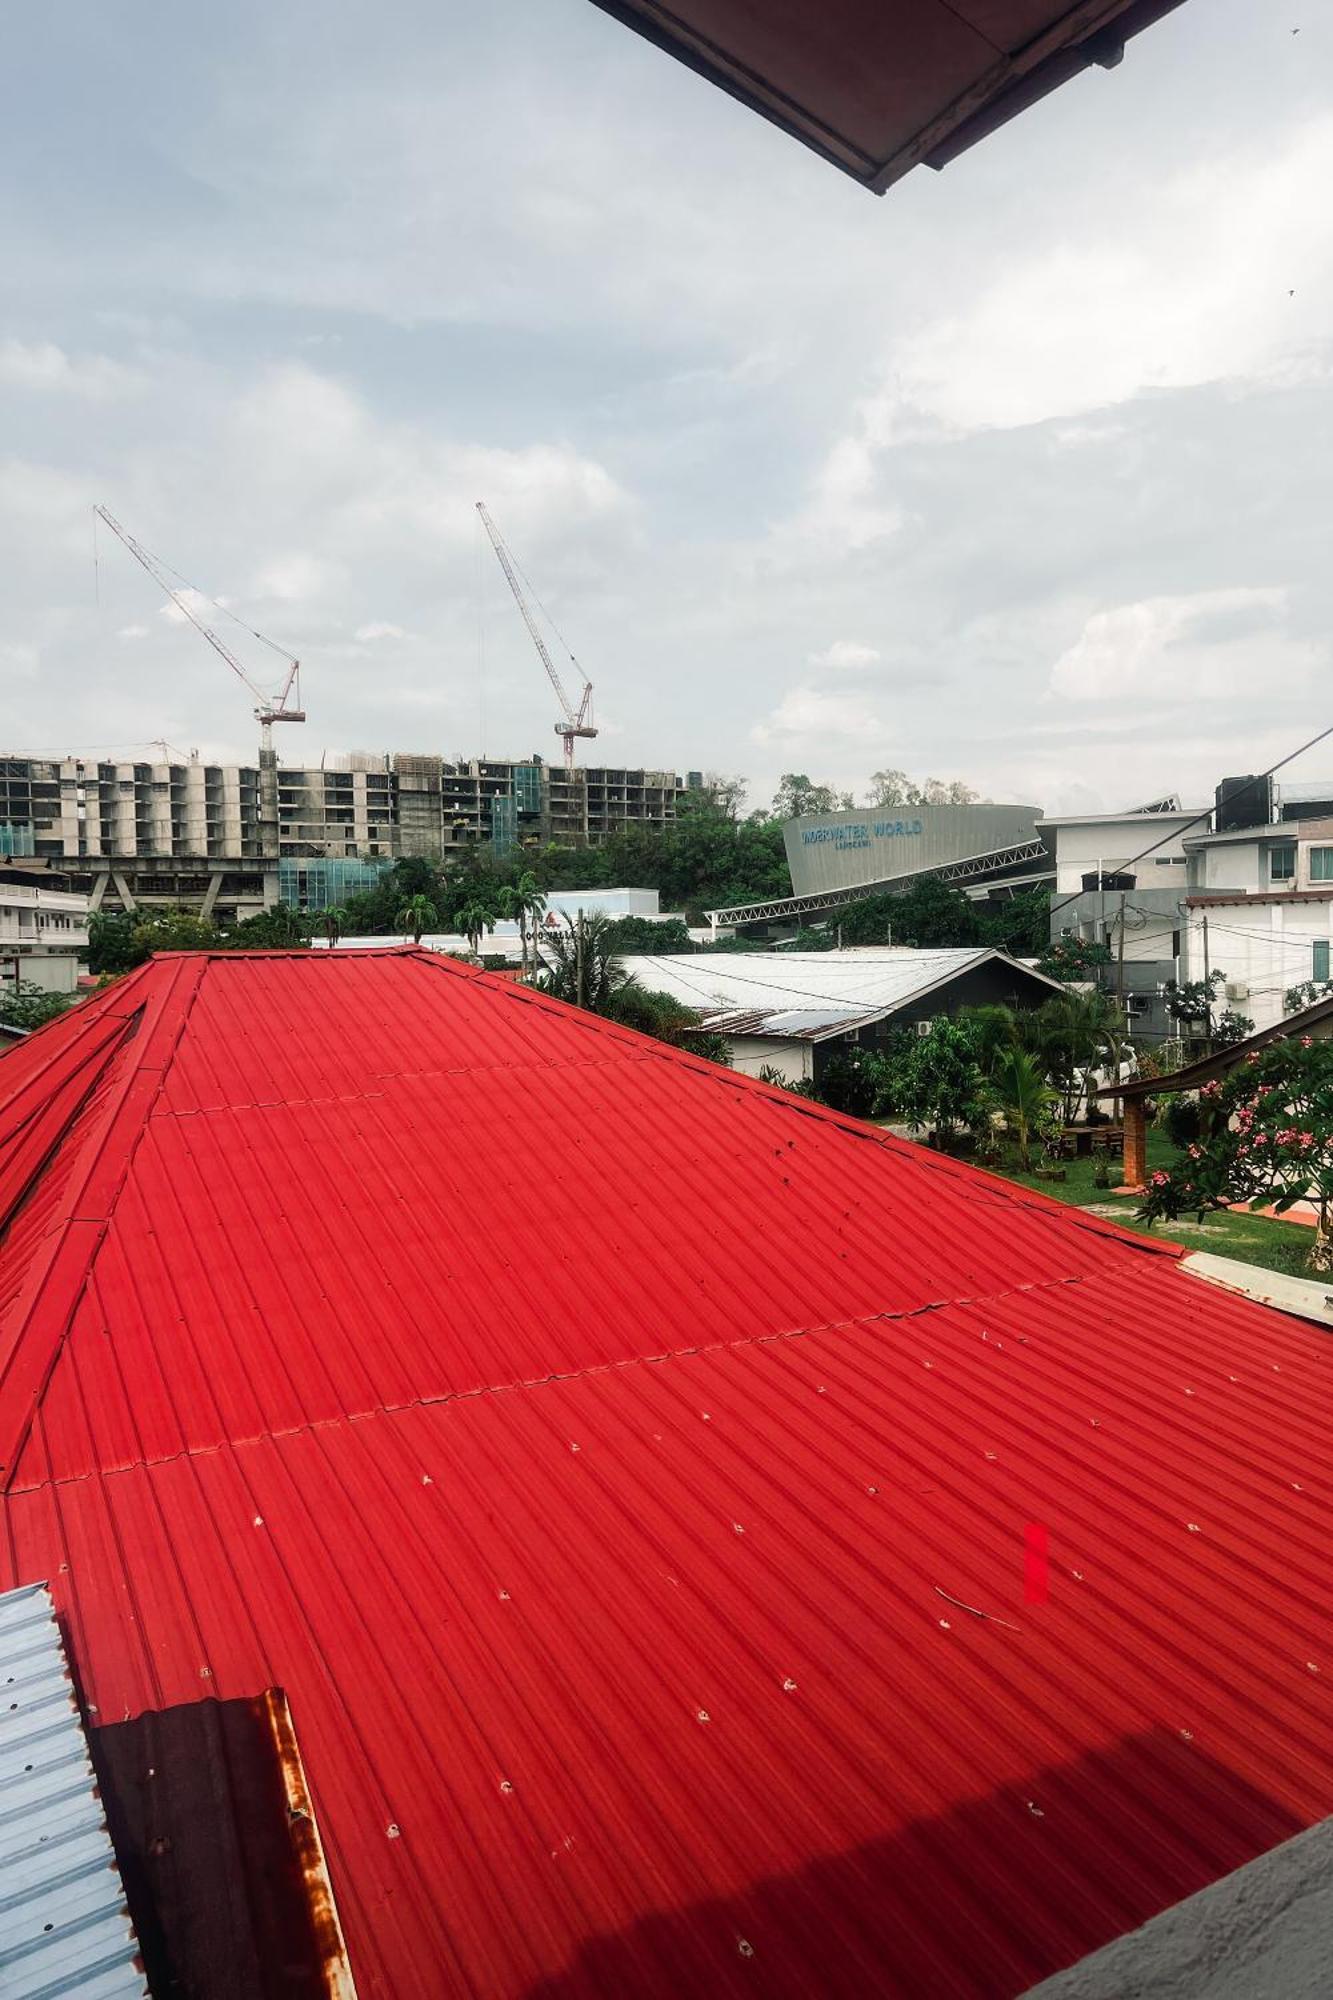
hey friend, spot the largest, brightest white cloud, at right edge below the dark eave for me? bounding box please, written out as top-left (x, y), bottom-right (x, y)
top-left (867, 116), bottom-right (1333, 444)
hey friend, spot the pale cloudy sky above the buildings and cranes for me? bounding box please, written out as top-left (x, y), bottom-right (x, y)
top-left (0, 0), bottom-right (1333, 810)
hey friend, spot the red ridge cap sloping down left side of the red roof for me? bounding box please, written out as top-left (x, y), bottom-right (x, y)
top-left (0, 952), bottom-right (208, 1492)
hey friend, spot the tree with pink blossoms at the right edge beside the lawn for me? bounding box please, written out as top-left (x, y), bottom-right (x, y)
top-left (1141, 1034), bottom-right (1333, 1272)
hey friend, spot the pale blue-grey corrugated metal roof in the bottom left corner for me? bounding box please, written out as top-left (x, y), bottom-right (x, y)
top-left (0, 1584), bottom-right (148, 2000)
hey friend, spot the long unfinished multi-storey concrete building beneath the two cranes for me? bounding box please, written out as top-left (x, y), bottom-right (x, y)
top-left (0, 754), bottom-right (701, 922)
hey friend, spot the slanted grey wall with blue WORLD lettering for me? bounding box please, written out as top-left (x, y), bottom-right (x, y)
top-left (783, 806), bottom-right (1041, 896)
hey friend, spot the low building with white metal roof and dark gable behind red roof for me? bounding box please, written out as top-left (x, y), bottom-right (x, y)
top-left (620, 946), bottom-right (1065, 1084)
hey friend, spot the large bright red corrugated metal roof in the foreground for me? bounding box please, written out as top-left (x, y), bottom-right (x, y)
top-left (0, 952), bottom-right (1333, 2000)
